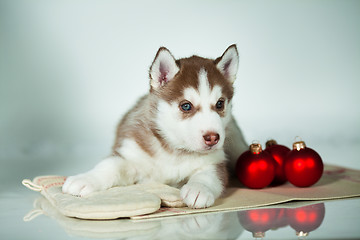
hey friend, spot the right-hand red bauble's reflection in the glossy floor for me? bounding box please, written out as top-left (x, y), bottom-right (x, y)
top-left (286, 203), bottom-right (325, 235)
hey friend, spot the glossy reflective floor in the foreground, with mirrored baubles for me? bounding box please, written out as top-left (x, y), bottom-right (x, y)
top-left (0, 189), bottom-right (360, 239)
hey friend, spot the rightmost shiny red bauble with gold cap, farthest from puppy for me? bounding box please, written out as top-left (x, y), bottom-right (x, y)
top-left (285, 141), bottom-right (324, 187)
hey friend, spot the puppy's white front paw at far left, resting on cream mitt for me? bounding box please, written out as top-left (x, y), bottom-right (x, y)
top-left (62, 173), bottom-right (102, 197)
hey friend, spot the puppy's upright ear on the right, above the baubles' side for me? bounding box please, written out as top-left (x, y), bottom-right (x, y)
top-left (215, 44), bottom-right (239, 83)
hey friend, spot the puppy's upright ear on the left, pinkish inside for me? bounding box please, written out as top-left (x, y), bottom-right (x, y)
top-left (150, 47), bottom-right (179, 89)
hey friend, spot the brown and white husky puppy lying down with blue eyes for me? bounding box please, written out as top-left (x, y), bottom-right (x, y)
top-left (62, 45), bottom-right (247, 208)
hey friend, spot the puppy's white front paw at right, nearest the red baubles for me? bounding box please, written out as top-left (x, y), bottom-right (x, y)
top-left (180, 183), bottom-right (215, 208)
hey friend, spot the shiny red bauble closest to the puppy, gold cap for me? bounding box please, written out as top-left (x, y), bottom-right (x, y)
top-left (236, 144), bottom-right (275, 189)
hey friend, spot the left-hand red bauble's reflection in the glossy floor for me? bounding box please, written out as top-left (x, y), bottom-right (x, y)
top-left (238, 208), bottom-right (279, 238)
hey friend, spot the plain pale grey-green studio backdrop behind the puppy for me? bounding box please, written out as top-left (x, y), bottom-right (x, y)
top-left (0, 0), bottom-right (360, 190)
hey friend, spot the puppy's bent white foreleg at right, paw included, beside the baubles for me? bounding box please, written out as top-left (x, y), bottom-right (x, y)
top-left (180, 165), bottom-right (225, 208)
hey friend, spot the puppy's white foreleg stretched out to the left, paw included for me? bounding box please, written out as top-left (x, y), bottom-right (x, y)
top-left (62, 156), bottom-right (136, 196)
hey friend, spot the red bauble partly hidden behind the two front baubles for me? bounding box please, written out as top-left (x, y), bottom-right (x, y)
top-left (264, 140), bottom-right (290, 185)
